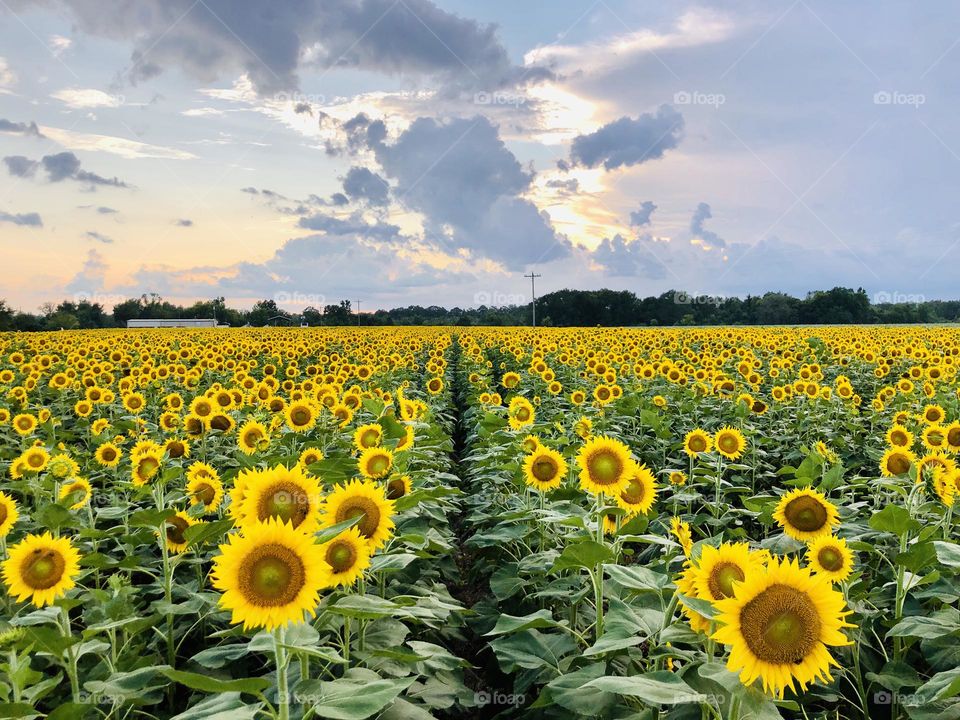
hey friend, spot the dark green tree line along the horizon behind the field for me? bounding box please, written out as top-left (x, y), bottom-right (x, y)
top-left (0, 287), bottom-right (960, 332)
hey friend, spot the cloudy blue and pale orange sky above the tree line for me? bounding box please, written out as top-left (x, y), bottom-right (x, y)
top-left (0, 0), bottom-right (960, 311)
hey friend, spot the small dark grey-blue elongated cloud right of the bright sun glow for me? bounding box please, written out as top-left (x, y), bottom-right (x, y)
top-left (570, 105), bottom-right (684, 170)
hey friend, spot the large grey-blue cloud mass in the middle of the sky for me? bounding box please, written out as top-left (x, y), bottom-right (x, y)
top-left (373, 116), bottom-right (570, 269)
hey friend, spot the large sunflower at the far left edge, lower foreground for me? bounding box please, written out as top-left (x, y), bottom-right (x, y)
top-left (3, 532), bottom-right (80, 607)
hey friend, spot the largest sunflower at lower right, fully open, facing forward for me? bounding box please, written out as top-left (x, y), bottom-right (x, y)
top-left (713, 560), bottom-right (852, 698)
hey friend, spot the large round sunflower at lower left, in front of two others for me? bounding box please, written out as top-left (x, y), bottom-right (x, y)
top-left (212, 518), bottom-right (330, 630)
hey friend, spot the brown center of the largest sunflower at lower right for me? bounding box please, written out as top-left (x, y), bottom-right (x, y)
top-left (740, 585), bottom-right (821, 665)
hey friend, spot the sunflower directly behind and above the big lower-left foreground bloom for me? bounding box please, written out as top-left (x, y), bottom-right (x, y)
top-left (237, 465), bottom-right (321, 533)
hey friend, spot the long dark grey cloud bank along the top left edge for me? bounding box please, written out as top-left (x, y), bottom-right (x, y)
top-left (20, 0), bottom-right (550, 95)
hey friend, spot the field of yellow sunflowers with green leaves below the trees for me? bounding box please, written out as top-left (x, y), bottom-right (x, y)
top-left (0, 327), bottom-right (960, 720)
